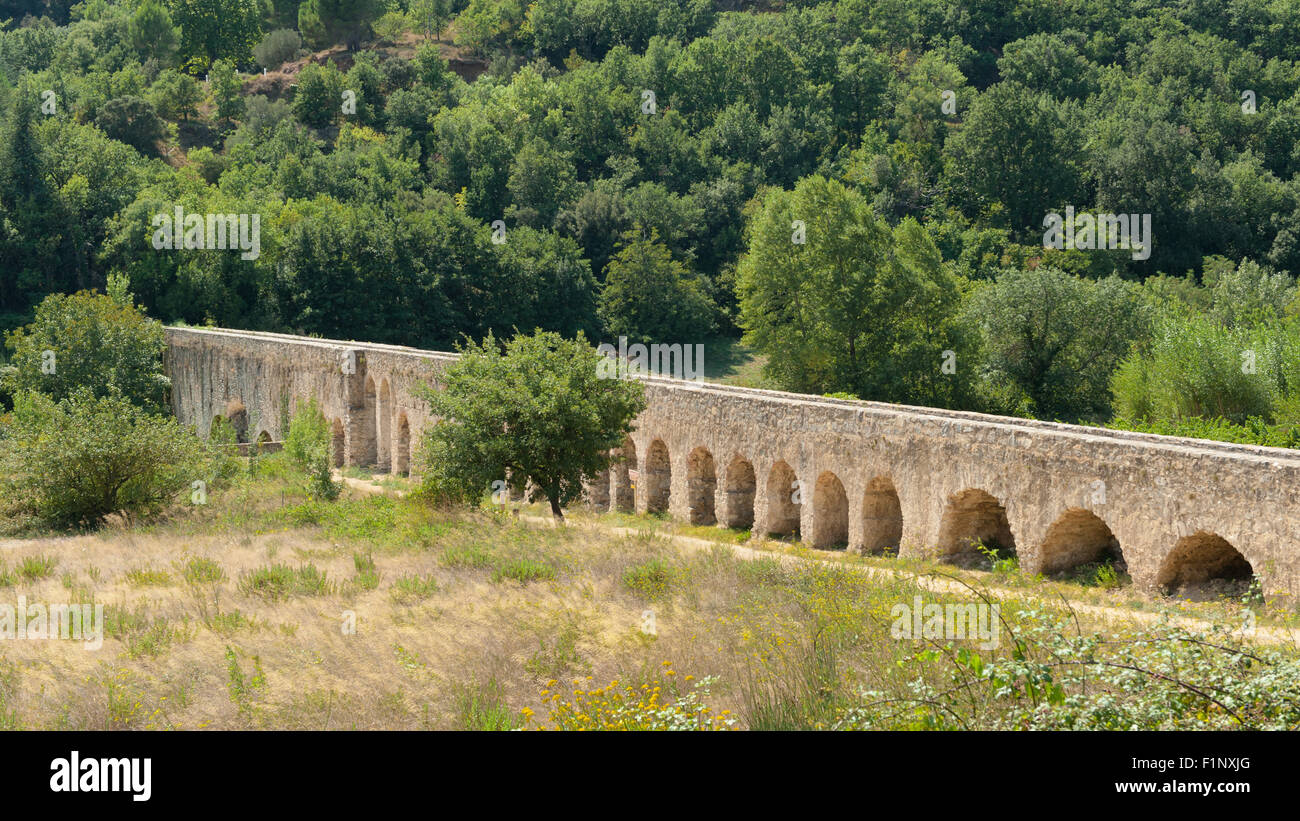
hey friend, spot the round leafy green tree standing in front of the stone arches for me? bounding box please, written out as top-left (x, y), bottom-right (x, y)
top-left (421, 331), bottom-right (645, 521)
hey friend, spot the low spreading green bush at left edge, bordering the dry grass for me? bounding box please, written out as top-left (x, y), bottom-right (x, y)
top-left (0, 388), bottom-right (209, 527)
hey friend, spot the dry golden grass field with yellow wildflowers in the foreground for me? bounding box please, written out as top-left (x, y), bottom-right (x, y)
top-left (0, 455), bottom-right (1292, 730)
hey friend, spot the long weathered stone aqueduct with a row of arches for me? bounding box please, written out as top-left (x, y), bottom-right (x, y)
top-left (166, 327), bottom-right (1300, 601)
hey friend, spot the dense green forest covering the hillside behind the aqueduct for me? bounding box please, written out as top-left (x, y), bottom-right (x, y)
top-left (0, 0), bottom-right (1300, 446)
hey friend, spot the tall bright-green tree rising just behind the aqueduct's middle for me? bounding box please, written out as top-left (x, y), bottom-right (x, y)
top-left (737, 175), bottom-right (962, 404)
